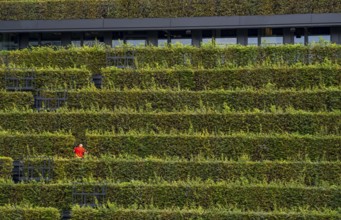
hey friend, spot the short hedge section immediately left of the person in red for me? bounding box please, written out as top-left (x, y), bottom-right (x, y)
top-left (0, 131), bottom-right (75, 159)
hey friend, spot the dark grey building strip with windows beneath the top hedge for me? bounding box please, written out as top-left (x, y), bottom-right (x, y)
top-left (0, 0), bottom-right (341, 50)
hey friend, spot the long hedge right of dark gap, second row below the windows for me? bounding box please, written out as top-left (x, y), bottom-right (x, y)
top-left (102, 66), bottom-right (341, 90)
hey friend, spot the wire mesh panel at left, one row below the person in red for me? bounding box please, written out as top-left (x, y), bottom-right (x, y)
top-left (14, 157), bottom-right (53, 182)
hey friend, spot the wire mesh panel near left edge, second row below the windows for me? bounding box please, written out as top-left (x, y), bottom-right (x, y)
top-left (5, 68), bottom-right (36, 91)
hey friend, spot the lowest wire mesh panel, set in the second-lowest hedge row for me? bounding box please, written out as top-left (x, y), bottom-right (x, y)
top-left (72, 183), bottom-right (107, 207)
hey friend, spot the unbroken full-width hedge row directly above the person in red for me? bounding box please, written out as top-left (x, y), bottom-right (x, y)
top-left (0, 110), bottom-right (341, 137)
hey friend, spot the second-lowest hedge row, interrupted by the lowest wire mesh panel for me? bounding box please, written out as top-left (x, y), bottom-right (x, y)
top-left (0, 182), bottom-right (341, 211)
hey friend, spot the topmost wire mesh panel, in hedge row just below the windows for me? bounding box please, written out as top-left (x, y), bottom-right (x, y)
top-left (106, 50), bottom-right (136, 69)
